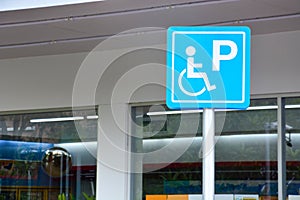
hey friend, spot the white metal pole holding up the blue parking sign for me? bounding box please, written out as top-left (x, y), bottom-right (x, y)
top-left (202, 108), bottom-right (215, 200)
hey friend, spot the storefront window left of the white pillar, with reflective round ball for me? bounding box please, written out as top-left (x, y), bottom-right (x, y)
top-left (0, 109), bottom-right (97, 200)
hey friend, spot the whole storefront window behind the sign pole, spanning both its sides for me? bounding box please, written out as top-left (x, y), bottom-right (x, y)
top-left (132, 99), bottom-right (278, 200)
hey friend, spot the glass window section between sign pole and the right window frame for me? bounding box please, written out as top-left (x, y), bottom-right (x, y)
top-left (215, 99), bottom-right (278, 200)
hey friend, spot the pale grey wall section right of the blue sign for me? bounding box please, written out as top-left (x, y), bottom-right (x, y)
top-left (251, 31), bottom-right (300, 94)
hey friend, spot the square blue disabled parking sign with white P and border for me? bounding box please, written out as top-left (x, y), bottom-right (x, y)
top-left (166, 26), bottom-right (250, 109)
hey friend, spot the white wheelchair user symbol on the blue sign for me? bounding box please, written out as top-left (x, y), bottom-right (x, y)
top-left (178, 46), bottom-right (216, 97)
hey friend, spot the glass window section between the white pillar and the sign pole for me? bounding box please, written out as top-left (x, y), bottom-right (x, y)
top-left (132, 106), bottom-right (202, 200)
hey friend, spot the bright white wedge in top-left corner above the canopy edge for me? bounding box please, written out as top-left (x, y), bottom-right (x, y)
top-left (0, 0), bottom-right (104, 11)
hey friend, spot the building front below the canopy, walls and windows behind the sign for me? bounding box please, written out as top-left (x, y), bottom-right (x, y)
top-left (0, 0), bottom-right (300, 200)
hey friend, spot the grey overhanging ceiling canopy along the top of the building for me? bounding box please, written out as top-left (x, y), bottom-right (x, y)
top-left (0, 0), bottom-right (300, 59)
